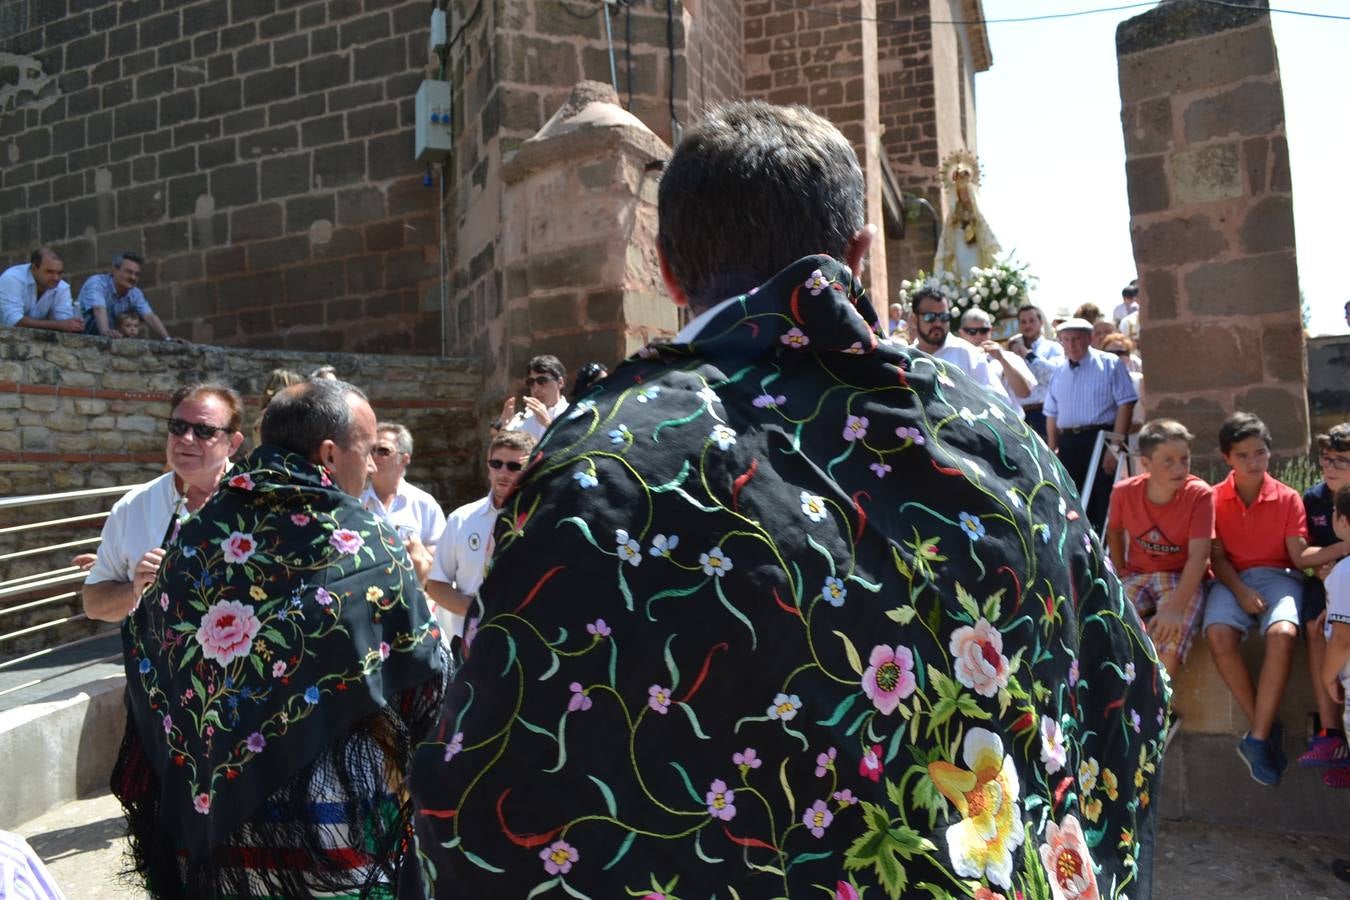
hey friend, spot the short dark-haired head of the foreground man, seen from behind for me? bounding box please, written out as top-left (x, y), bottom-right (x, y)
top-left (656, 100), bottom-right (865, 312)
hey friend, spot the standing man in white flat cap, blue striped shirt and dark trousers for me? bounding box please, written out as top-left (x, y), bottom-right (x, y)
top-left (1045, 318), bottom-right (1139, 532)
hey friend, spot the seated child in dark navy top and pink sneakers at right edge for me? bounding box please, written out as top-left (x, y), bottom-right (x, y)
top-left (1299, 422), bottom-right (1350, 766)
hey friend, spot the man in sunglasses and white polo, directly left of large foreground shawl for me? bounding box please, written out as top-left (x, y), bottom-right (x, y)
top-left (427, 430), bottom-right (535, 644)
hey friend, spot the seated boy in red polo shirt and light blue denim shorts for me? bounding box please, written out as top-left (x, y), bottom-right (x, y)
top-left (1204, 413), bottom-right (1308, 787)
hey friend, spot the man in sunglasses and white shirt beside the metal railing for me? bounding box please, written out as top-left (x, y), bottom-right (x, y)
top-left (82, 385), bottom-right (244, 622)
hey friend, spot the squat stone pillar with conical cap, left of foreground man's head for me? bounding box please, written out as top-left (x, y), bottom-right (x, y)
top-left (499, 81), bottom-right (678, 403)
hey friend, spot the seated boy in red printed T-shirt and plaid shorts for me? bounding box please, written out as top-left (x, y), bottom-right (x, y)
top-left (1106, 418), bottom-right (1214, 677)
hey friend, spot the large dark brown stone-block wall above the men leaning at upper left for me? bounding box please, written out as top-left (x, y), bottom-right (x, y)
top-left (0, 0), bottom-right (440, 354)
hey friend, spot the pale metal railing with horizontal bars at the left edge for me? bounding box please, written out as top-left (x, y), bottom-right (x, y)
top-left (0, 484), bottom-right (135, 696)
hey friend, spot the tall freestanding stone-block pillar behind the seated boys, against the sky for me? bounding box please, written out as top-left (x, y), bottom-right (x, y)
top-left (1116, 0), bottom-right (1308, 455)
